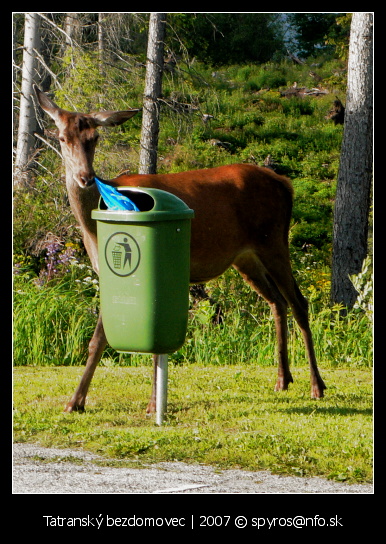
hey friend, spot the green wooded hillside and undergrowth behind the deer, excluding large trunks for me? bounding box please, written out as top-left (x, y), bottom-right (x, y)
top-left (13, 13), bottom-right (373, 480)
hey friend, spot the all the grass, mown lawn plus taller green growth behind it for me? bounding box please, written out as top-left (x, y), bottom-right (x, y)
top-left (14, 259), bottom-right (372, 482)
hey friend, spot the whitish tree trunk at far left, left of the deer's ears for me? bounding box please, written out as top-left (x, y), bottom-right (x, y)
top-left (14, 13), bottom-right (40, 186)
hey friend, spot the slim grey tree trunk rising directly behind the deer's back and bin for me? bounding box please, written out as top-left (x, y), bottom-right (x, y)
top-left (138, 13), bottom-right (166, 174)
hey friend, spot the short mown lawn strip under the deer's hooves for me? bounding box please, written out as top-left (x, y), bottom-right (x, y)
top-left (14, 364), bottom-right (373, 483)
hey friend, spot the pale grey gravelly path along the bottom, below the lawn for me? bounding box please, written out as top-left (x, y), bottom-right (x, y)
top-left (13, 444), bottom-right (373, 494)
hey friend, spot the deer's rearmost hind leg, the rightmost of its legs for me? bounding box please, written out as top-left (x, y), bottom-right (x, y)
top-left (264, 251), bottom-right (326, 399)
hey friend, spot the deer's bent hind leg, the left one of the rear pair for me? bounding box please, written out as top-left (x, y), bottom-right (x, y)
top-left (233, 252), bottom-right (293, 391)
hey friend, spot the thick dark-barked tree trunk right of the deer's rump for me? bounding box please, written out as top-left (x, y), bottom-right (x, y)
top-left (331, 13), bottom-right (373, 308)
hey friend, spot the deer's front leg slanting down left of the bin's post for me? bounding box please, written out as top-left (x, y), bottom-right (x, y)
top-left (64, 315), bottom-right (107, 412)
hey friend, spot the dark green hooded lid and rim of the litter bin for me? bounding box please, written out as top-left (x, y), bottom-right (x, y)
top-left (91, 187), bottom-right (194, 223)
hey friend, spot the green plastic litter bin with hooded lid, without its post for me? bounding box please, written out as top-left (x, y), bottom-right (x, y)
top-left (91, 187), bottom-right (194, 354)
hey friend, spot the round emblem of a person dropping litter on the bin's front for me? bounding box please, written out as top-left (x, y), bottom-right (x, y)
top-left (105, 232), bottom-right (141, 276)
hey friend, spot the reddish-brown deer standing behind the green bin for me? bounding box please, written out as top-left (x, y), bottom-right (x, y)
top-left (34, 86), bottom-right (326, 415)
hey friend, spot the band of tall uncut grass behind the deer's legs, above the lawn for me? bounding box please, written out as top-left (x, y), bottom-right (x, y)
top-left (14, 264), bottom-right (372, 368)
